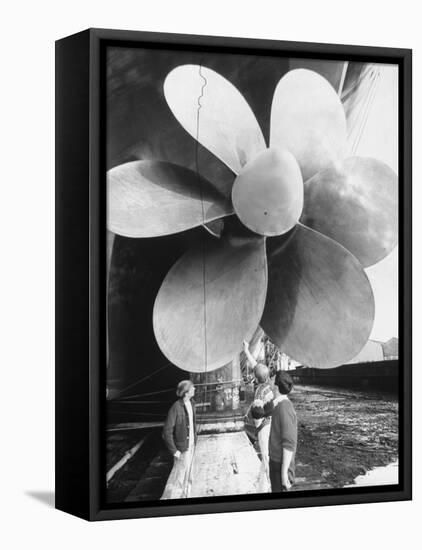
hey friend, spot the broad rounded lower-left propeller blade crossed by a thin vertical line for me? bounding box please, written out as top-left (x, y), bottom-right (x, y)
top-left (153, 238), bottom-right (267, 372)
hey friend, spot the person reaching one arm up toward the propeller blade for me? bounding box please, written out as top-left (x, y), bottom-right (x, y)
top-left (243, 341), bottom-right (274, 493)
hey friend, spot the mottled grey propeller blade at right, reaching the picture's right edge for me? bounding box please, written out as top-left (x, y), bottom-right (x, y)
top-left (301, 157), bottom-right (398, 267)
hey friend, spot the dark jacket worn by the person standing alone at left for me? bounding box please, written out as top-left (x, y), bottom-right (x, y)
top-left (163, 399), bottom-right (197, 455)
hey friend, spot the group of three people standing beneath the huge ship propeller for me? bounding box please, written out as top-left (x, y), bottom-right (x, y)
top-left (163, 342), bottom-right (297, 497)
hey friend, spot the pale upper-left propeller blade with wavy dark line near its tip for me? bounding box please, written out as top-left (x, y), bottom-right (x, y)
top-left (164, 65), bottom-right (266, 174)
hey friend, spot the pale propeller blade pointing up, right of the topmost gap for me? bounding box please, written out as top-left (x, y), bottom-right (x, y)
top-left (270, 69), bottom-right (346, 181)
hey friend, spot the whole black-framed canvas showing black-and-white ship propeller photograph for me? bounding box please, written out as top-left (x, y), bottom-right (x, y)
top-left (56, 29), bottom-right (411, 520)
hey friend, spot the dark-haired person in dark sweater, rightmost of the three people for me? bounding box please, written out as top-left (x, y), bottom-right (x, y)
top-left (269, 371), bottom-right (297, 493)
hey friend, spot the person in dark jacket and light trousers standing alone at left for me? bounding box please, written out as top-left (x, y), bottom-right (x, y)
top-left (163, 380), bottom-right (197, 498)
